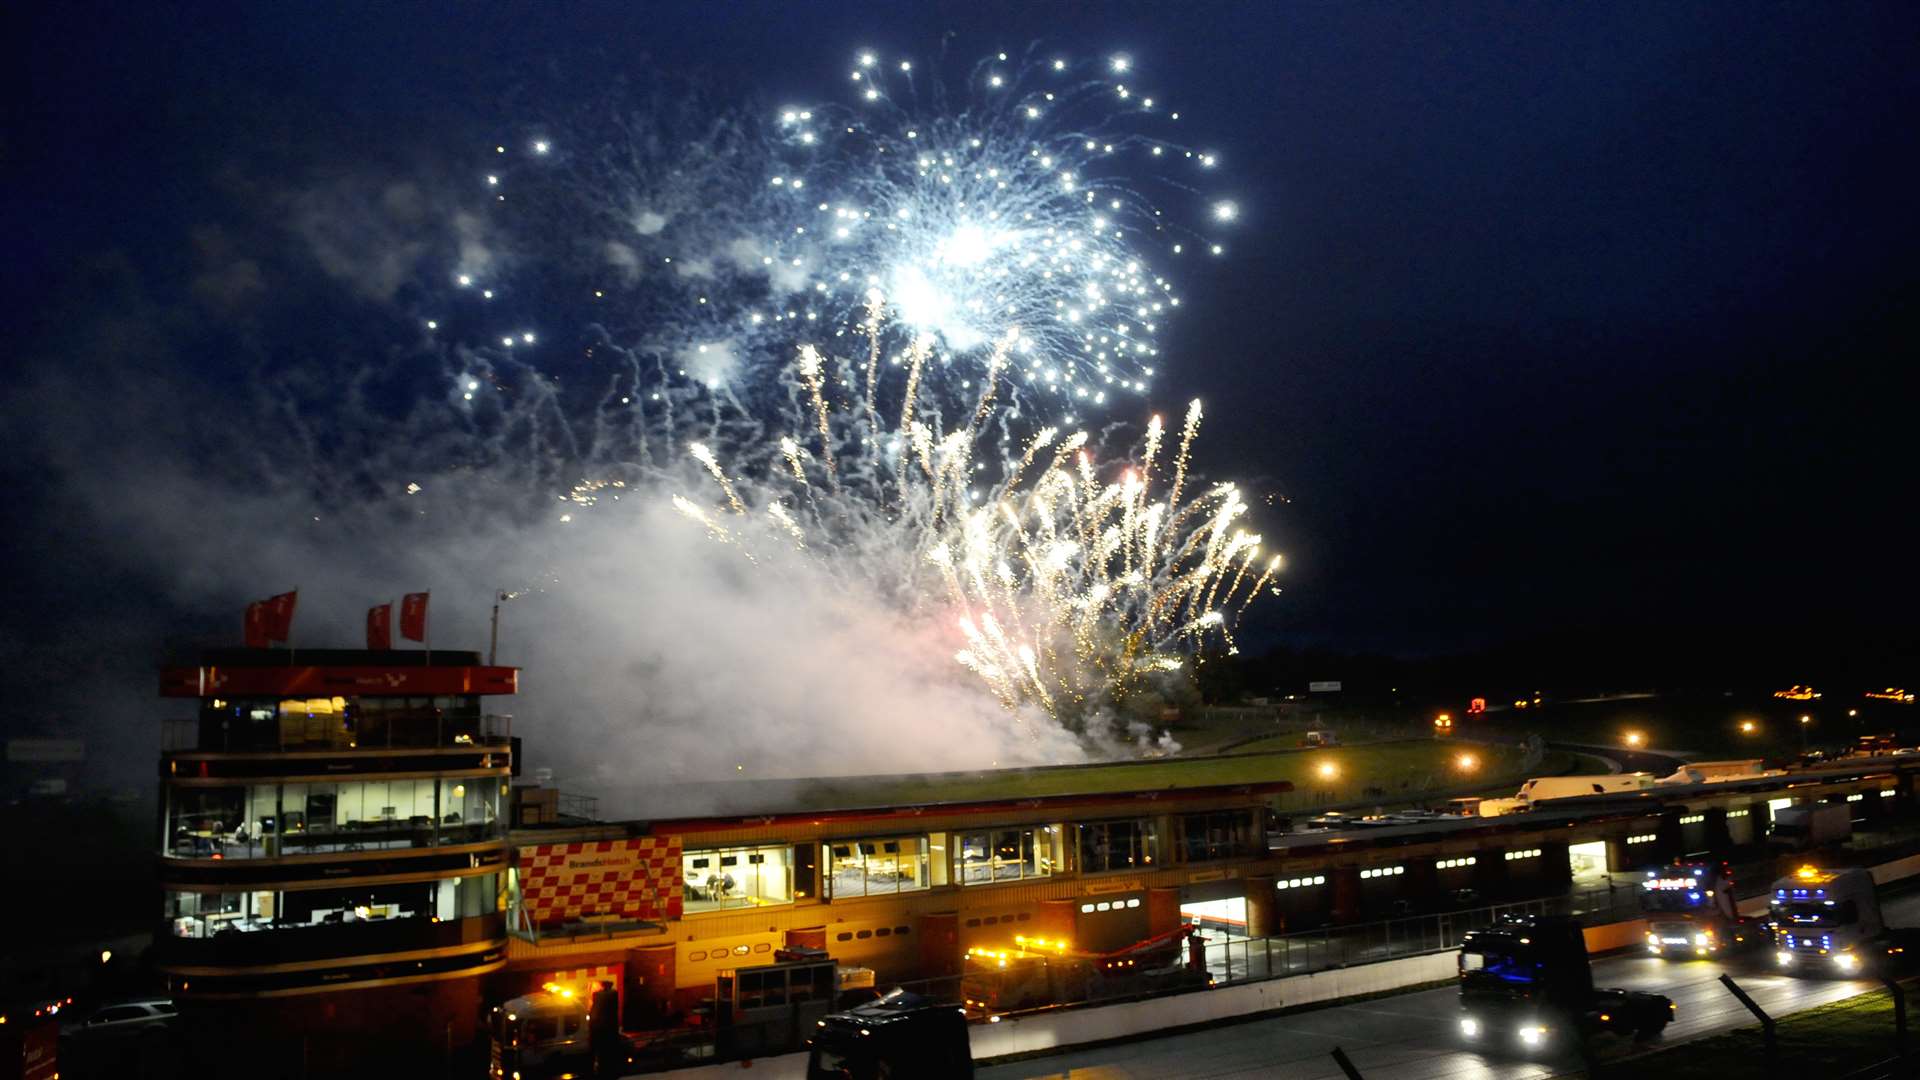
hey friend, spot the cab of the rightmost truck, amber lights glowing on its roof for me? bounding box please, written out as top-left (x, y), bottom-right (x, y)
top-left (1768, 867), bottom-right (1885, 974)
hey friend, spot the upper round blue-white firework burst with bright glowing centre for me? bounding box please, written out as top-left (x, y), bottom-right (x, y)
top-left (768, 52), bottom-right (1236, 409)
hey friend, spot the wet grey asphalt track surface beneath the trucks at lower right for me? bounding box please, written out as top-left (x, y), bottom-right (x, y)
top-left (977, 894), bottom-right (1920, 1080)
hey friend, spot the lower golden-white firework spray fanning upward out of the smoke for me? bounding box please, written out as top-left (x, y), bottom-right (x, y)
top-left (674, 307), bottom-right (1281, 724)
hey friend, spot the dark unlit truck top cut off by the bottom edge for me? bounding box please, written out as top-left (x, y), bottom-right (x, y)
top-left (806, 990), bottom-right (973, 1080)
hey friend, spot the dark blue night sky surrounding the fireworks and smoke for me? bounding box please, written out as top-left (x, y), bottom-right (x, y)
top-left (0, 2), bottom-right (1920, 757)
